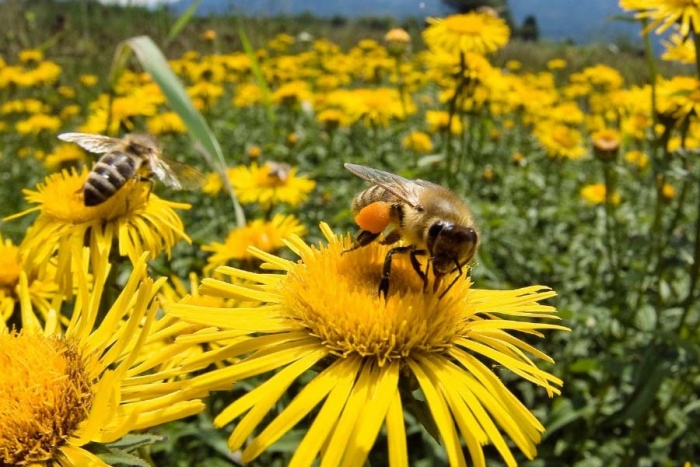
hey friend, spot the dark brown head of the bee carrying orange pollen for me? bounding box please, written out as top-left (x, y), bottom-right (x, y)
top-left (427, 221), bottom-right (479, 276)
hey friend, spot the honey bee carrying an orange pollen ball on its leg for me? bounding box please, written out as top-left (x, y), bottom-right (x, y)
top-left (344, 164), bottom-right (479, 298)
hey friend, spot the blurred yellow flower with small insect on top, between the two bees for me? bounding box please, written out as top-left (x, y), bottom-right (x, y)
top-left (228, 162), bottom-right (316, 210)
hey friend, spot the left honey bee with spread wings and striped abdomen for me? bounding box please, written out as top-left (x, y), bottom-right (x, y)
top-left (58, 133), bottom-right (204, 206)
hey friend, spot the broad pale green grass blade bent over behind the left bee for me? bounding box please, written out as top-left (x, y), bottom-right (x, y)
top-left (110, 36), bottom-right (245, 227)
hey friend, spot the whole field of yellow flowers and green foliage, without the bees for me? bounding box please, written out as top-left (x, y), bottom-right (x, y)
top-left (0, 0), bottom-right (700, 466)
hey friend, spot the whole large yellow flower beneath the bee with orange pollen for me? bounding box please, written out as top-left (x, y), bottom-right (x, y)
top-left (166, 224), bottom-right (566, 466)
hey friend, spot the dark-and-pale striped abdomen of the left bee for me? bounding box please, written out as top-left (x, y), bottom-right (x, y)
top-left (83, 151), bottom-right (140, 206)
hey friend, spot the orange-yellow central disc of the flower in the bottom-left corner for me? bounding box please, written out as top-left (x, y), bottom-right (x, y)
top-left (0, 333), bottom-right (92, 465)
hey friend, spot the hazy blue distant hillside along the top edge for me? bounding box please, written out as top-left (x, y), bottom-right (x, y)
top-left (172, 0), bottom-right (639, 44)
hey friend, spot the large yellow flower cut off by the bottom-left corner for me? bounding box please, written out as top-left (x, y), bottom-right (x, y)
top-left (0, 249), bottom-right (207, 467)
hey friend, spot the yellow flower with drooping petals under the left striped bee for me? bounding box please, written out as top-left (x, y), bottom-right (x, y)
top-left (5, 167), bottom-right (190, 293)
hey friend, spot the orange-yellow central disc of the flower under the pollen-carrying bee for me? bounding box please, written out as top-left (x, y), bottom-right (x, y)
top-left (279, 239), bottom-right (470, 365)
